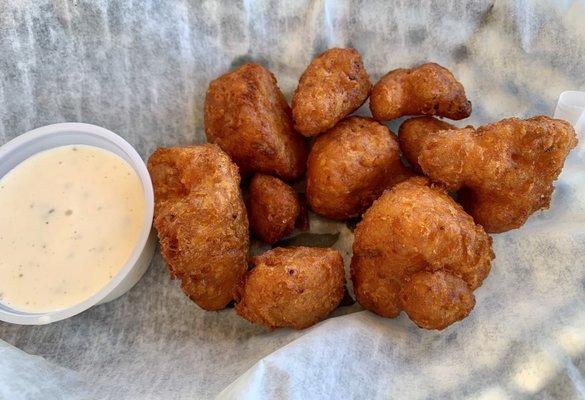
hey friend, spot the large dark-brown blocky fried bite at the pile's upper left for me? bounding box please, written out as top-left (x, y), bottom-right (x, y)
top-left (205, 64), bottom-right (307, 180)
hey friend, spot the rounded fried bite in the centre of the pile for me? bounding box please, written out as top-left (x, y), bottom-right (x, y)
top-left (306, 117), bottom-right (412, 220)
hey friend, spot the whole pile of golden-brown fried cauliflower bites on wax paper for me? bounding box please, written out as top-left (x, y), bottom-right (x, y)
top-left (148, 48), bottom-right (577, 329)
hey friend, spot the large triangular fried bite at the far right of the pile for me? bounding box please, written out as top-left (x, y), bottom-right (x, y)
top-left (417, 116), bottom-right (577, 233)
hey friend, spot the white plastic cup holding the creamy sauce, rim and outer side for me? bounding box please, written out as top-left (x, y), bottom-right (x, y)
top-left (0, 123), bottom-right (156, 325)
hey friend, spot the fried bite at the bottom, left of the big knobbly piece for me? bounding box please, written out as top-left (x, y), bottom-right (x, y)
top-left (236, 247), bottom-right (345, 329)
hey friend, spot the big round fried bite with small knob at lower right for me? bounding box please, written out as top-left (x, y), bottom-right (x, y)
top-left (351, 177), bottom-right (494, 329)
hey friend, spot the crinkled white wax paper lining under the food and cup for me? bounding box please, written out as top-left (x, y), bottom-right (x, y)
top-left (0, 0), bottom-right (585, 400)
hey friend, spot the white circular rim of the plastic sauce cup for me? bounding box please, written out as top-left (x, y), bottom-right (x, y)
top-left (0, 122), bottom-right (154, 325)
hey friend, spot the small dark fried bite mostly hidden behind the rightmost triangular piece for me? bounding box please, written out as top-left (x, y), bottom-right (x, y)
top-left (398, 117), bottom-right (457, 172)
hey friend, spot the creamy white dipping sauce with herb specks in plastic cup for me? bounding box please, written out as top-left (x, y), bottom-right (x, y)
top-left (0, 145), bottom-right (146, 312)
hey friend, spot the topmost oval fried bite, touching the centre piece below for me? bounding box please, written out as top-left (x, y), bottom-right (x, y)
top-left (292, 48), bottom-right (372, 136)
